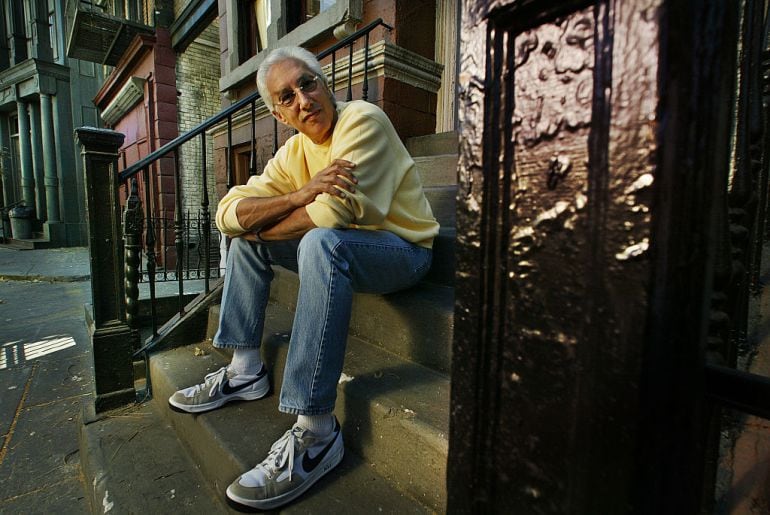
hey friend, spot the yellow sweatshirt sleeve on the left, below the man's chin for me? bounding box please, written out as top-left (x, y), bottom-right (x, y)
top-left (216, 141), bottom-right (298, 236)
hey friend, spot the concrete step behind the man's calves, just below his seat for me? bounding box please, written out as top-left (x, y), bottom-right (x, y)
top-left (255, 266), bottom-right (454, 373)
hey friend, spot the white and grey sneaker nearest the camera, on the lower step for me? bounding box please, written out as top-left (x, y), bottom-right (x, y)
top-left (227, 418), bottom-right (345, 510)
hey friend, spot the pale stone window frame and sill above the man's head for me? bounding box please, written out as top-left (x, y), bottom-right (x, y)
top-left (219, 0), bottom-right (364, 91)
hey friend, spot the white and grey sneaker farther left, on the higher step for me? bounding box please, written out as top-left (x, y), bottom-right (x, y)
top-left (168, 364), bottom-right (270, 413)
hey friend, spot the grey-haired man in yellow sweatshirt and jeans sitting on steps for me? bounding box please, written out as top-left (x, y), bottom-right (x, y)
top-left (169, 47), bottom-right (438, 509)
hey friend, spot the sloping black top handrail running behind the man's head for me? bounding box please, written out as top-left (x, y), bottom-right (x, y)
top-left (118, 18), bottom-right (393, 184)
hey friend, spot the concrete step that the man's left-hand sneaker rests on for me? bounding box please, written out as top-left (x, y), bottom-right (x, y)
top-left (150, 303), bottom-right (449, 513)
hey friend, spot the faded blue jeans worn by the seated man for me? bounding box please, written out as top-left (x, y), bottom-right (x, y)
top-left (214, 228), bottom-right (432, 415)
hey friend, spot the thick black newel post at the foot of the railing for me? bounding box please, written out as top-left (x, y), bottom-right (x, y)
top-left (75, 127), bottom-right (136, 412)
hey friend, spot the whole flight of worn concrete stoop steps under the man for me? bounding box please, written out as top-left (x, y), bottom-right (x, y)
top-left (81, 133), bottom-right (457, 513)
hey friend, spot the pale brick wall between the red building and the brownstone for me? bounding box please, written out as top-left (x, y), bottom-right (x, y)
top-left (176, 20), bottom-right (222, 216)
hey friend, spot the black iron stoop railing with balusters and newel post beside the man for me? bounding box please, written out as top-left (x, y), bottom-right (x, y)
top-left (77, 19), bottom-right (392, 408)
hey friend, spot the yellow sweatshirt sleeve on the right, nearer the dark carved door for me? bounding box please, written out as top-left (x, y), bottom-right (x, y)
top-left (306, 106), bottom-right (413, 227)
